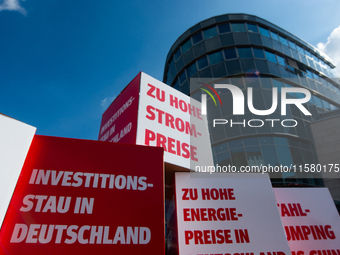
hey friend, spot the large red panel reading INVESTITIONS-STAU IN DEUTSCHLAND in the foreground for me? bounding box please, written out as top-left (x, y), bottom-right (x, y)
top-left (0, 136), bottom-right (165, 255)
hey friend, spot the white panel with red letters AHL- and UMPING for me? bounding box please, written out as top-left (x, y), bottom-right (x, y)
top-left (274, 188), bottom-right (340, 255)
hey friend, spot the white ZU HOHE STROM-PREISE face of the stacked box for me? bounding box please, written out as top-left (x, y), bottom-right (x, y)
top-left (136, 73), bottom-right (213, 170)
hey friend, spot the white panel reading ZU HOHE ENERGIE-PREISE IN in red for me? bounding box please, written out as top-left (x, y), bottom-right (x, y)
top-left (171, 173), bottom-right (290, 255)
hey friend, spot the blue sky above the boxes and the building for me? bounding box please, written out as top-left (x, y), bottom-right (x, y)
top-left (0, 0), bottom-right (340, 140)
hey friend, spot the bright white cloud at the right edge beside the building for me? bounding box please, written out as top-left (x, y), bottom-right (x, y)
top-left (317, 26), bottom-right (340, 77)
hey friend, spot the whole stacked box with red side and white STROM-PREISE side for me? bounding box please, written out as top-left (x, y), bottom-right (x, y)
top-left (99, 73), bottom-right (213, 170)
